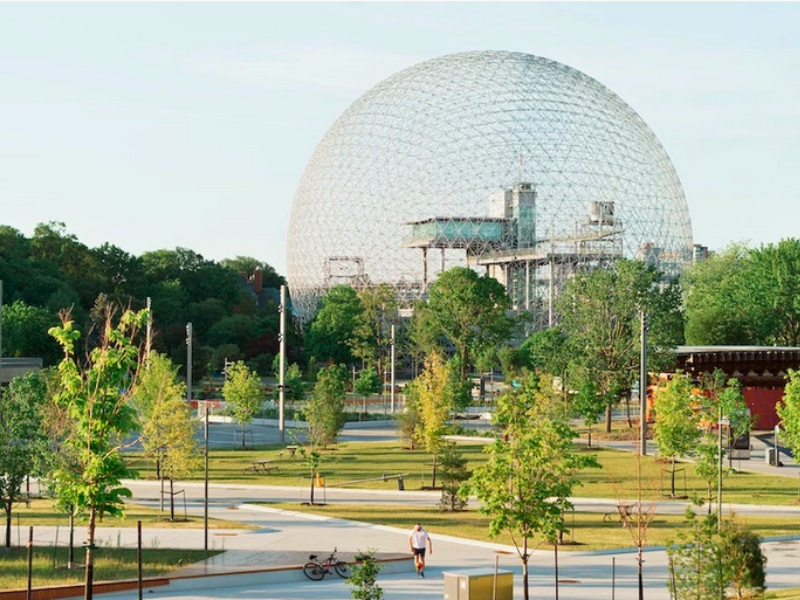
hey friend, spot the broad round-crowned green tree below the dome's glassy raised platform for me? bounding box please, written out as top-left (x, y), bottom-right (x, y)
top-left (415, 267), bottom-right (514, 380)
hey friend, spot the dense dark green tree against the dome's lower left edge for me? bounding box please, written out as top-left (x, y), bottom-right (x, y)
top-left (306, 285), bottom-right (362, 365)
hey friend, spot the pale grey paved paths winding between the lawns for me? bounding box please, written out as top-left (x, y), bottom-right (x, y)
top-left (17, 424), bottom-right (800, 600)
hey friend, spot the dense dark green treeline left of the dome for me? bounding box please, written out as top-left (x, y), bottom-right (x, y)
top-left (0, 223), bottom-right (301, 378)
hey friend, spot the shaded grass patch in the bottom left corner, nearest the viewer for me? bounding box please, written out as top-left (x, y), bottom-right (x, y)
top-left (0, 547), bottom-right (218, 590)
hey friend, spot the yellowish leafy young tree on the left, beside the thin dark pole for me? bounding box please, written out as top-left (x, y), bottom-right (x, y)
top-left (132, 352), bottom-right (200, 521)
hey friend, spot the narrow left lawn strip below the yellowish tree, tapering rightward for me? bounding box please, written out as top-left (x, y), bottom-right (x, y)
top-left (9, 499), bottom-right (257, 528)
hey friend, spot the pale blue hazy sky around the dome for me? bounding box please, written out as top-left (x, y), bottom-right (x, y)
top-left (0, 2), bottom-right (800, 274)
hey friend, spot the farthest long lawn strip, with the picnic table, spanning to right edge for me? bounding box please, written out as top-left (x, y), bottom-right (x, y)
top-left (123, 442), bottom-right (800, 505)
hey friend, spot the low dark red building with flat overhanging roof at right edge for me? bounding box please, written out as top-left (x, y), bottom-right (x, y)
top-left (677, 346), bottom-right (800, 430)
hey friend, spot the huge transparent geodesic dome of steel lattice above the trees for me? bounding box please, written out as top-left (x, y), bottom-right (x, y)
top-left (288, 52), bottom-right (692, 326)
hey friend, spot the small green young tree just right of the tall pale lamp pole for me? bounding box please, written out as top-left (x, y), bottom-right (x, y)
top-left (303, 365), bottom-right (349, 448)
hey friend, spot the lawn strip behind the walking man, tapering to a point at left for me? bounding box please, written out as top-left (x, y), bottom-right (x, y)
top-left (265, 503), bottom-right (800, 551)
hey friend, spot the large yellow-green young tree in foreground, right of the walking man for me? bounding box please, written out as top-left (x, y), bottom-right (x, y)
top-left (467, 376), bottom-right (597, 600)
